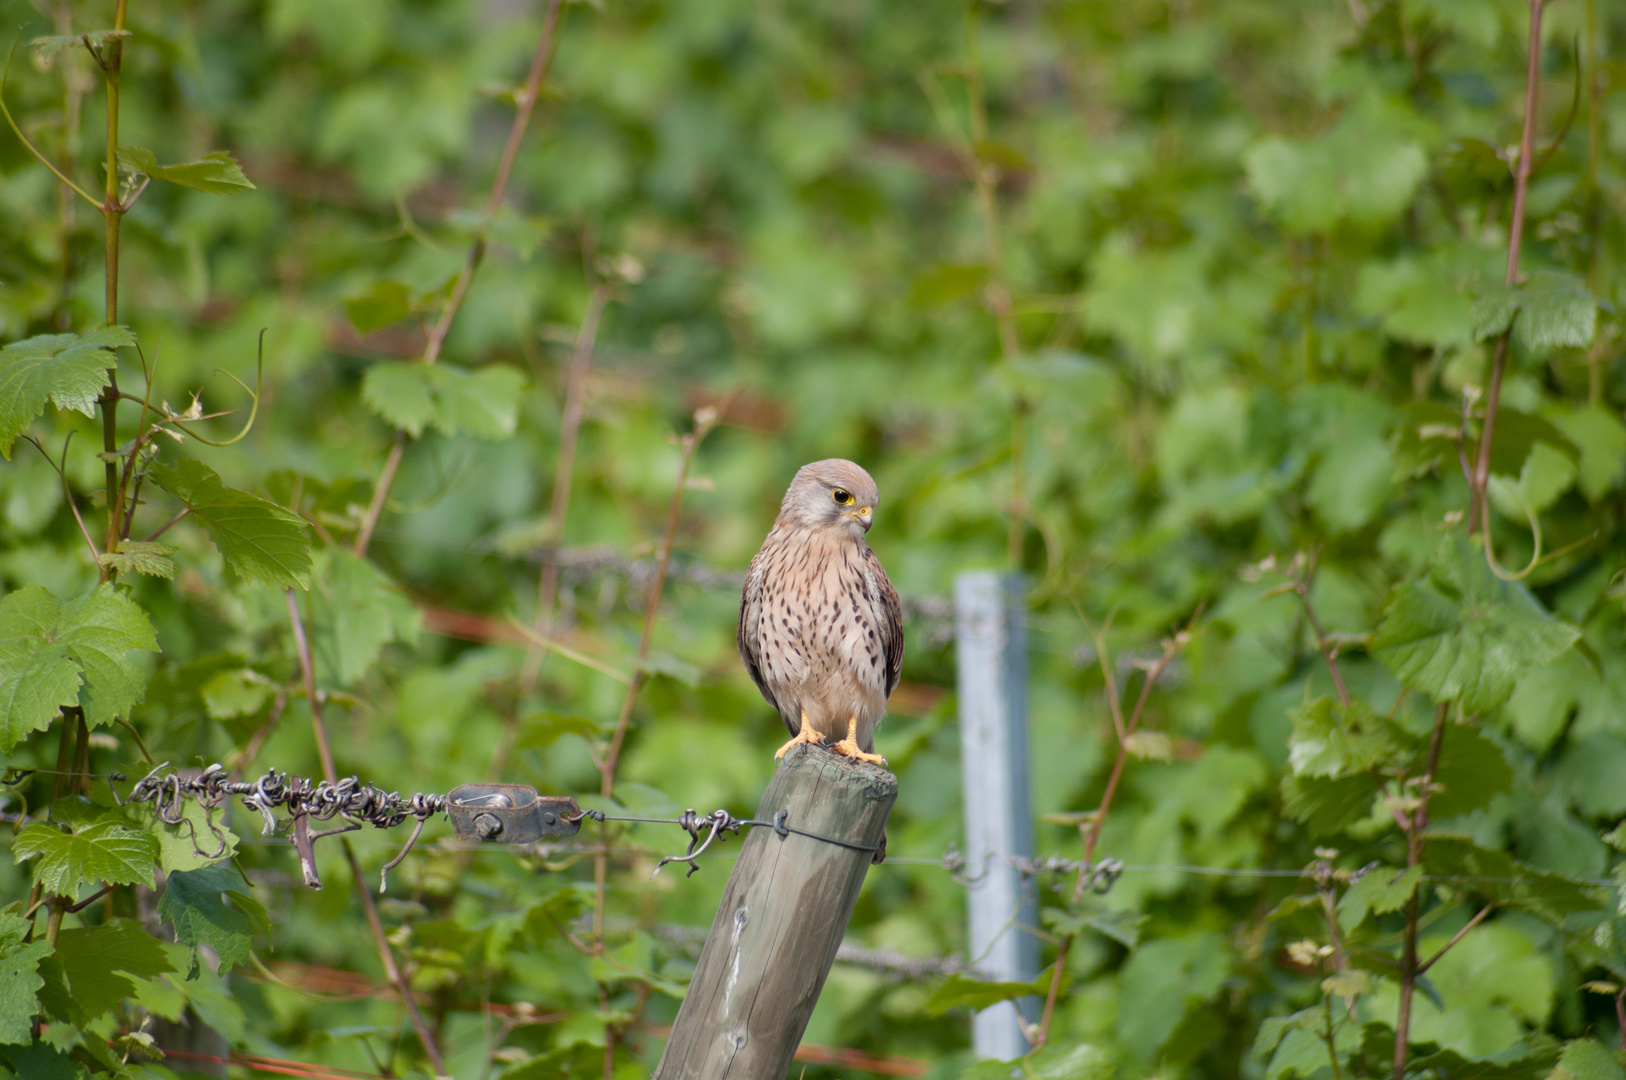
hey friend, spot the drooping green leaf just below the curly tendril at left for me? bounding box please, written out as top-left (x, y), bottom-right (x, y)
top-left (153, 459), bottom-right (311, 589)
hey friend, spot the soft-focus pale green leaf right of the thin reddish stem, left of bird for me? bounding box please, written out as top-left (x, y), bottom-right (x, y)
top-left (311, 548), bottom-right (420, 686)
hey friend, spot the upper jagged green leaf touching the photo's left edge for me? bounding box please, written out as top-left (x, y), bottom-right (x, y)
top-left (0, 327), bottom-right (135, 460)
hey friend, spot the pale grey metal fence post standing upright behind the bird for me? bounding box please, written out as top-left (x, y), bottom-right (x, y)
top-left (954, 571), bottom-right (1039, 1060)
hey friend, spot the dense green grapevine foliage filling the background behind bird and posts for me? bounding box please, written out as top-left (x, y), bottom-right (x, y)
top-left (0, 0), bottom-right (1626, 1080)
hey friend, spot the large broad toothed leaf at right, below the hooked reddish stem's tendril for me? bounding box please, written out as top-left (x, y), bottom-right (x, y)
top-left (1372, 537), bottom-right (1580, 712)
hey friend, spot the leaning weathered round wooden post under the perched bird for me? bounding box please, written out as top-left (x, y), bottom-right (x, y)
top-left (652, 747), bottom-right (898, 1080)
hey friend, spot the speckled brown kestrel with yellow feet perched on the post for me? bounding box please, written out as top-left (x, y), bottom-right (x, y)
top-left (740, 459), bottom-right (904, 764)
